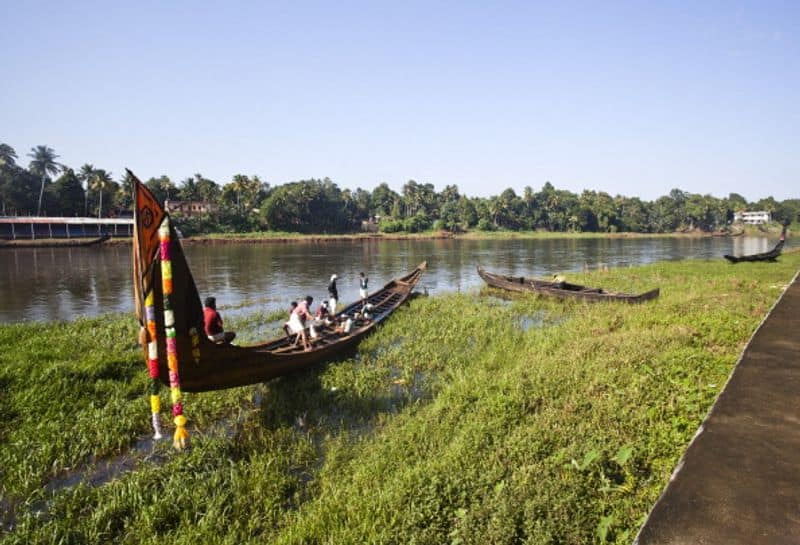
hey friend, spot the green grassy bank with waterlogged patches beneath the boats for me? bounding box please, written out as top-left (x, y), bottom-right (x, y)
top-left (0, 252), bottom-right (800, 544)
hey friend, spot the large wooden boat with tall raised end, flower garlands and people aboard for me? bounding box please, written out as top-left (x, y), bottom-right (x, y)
top-left (129, 171), bottom-right (427, 392)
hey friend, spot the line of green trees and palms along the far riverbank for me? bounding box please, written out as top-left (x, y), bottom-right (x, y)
top-left (0, 144), bottom-right (800, 235)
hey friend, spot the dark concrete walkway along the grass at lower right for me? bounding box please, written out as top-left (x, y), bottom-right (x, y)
top-left (634, 276), bottom-right (800, 545)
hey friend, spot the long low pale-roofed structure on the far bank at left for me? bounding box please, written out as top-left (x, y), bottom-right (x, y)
top-left (0, 216), bottom-right (133, 240)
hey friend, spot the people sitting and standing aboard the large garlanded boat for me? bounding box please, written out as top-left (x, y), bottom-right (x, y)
top-left (203, 272), bottom-right (372, 350)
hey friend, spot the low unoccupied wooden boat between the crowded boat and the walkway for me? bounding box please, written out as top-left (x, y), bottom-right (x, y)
top-left (478, 266), bottom-right (659, 303)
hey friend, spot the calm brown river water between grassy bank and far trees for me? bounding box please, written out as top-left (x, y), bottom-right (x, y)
top-left (0, 237), bottom-right (797, 323)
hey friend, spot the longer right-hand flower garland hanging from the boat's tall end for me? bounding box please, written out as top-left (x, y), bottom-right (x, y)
top-left (159, 217), bottom-right (189, 450)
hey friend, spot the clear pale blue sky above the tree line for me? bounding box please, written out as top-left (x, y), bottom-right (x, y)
top-left (0, 0), bottom-right (800, 201)
